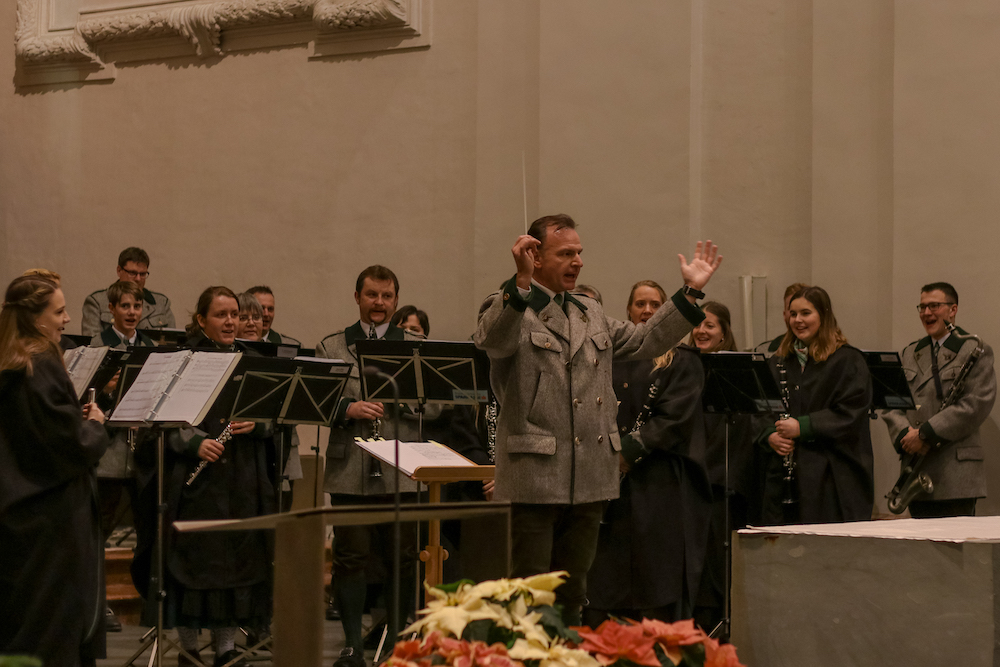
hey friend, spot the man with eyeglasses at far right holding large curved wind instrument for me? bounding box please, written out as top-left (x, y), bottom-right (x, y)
top-left (882, 283), bottom-right (997, 518)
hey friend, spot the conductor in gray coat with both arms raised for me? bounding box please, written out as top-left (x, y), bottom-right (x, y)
top-left (474, 215), bottom-right (722, 625)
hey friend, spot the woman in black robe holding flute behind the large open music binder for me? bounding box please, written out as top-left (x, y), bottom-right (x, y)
top-left (137, 287), bottom-right (275, 667)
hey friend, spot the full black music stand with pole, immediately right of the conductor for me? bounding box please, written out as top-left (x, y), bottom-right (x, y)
top-left (701, 352), bottom-right (783, 638)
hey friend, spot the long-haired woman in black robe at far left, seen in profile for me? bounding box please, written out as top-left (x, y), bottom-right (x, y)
top-left (0, 276), bottom-right (108, 667)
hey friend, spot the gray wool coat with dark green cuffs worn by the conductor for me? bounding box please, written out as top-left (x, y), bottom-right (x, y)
top-left (474, 278), bottom-right (704, 505)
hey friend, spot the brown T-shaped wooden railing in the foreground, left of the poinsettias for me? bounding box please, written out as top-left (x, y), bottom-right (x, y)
top-left (174, 504), bottom-right (510, 667)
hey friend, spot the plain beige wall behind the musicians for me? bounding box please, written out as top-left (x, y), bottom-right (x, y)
top-left (0, 0), bottom-right (1000, 513)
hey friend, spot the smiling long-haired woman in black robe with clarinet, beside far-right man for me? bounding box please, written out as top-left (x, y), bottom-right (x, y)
top-left (758, 287), bottom-right (875, 525)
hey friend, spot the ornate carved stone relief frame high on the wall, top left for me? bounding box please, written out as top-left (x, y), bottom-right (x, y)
top-left (15, 0), bottom-right (431, 85)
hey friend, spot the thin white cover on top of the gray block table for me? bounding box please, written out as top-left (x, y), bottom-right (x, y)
top-left (739, 516), bottom-right (1000, 543)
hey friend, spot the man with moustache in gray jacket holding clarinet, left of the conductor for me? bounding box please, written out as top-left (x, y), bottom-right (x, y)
top-left (316, 264), bottom-right (417, 667)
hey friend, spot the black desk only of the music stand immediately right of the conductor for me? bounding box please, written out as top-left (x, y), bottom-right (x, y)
top-left (701, 352), bottom-right (782, 414)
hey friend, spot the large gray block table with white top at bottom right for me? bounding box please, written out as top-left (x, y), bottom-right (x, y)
top-left (732, 517), bottom-right (1000, 667)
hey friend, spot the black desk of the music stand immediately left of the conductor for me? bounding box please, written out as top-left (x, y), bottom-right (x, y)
top-left (356, 339), bottom-right (490, 405)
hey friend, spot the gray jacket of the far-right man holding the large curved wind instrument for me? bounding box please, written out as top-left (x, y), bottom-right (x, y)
top-left (882, 328), bottom-right (997, 500)
